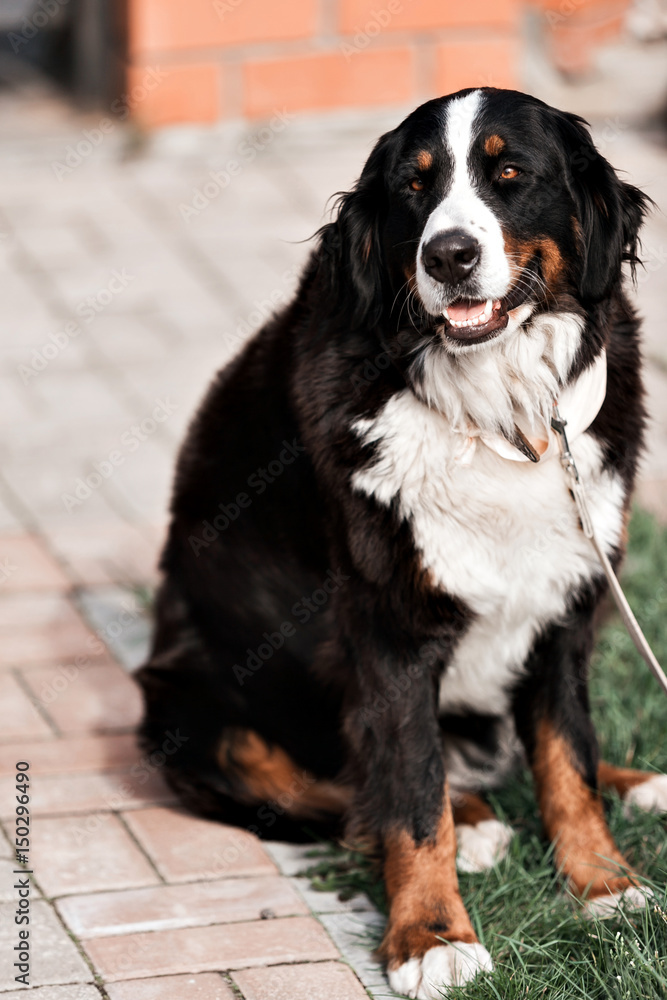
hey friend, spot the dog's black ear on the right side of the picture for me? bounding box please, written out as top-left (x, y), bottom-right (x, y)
top-left (558, 112), bottom-right (652, 303)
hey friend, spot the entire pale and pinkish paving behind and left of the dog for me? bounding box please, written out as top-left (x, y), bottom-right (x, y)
top-left (0, 60), bottom-right (667, 1000)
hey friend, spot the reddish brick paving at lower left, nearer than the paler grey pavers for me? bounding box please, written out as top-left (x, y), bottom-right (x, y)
top-left (0, 534), bottom-right (382, 1000)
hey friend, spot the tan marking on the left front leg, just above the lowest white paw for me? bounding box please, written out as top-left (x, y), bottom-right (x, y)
top-left (380, 789), bottom-right (478, 970)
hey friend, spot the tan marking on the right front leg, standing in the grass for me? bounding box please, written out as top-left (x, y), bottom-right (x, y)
top-left (533, 722), bottom-right (633, 899)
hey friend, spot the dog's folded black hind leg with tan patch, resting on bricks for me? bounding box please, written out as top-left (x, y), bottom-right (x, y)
top-left (136, 583), bottom-right (350, 840)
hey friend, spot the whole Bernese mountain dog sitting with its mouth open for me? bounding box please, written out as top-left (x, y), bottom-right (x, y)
top-left (138, 88), bottom-right (667, 998)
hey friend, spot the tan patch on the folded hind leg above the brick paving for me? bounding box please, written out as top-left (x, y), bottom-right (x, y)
top-left (218, 729), bottom-right (352, 819)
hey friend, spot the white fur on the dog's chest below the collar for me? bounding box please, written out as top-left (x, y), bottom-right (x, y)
top-left (352, 389), bottom-right (623, 714)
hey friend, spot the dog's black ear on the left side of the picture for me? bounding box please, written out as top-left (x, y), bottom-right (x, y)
top-left (316, 133), bottom-right (391, 326)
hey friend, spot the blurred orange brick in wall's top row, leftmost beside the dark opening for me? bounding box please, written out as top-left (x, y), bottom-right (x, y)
top-left (130, 0), bottom-right (317, 54)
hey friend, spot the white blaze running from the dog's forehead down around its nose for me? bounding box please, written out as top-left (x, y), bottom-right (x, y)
top-left (417, 90), bottom-right (510, 314)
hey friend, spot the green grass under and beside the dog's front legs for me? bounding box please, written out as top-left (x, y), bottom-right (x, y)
top-left (309, 511), bottom-right (667, 1000)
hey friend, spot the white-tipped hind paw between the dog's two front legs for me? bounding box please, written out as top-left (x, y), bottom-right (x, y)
top-left (452, 792), bottom-right (514, 872)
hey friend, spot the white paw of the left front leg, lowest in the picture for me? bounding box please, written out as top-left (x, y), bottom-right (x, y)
top-left (388, 941), bottom-right (493, 1000)
